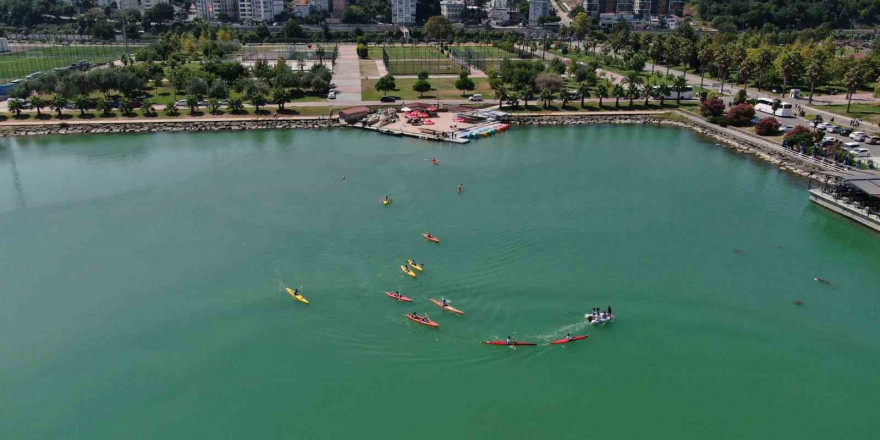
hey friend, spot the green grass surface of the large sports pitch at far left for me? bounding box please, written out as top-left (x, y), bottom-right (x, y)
top-left (0, 45), bottom-right (131, 83)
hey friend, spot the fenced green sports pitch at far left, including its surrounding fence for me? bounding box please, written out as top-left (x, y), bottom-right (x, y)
top-left (0, 41), bottom-right (138, 84)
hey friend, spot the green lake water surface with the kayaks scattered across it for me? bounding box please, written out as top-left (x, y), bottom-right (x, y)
top-left (0, 126), bottom-right (880, 440)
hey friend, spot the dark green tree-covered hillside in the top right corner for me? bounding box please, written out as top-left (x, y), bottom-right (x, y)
top-left (690, 0), bottom-right (880, 30)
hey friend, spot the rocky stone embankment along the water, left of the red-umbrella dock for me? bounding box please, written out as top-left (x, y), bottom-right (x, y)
top-left (0, 118), bottom-right (339, 136)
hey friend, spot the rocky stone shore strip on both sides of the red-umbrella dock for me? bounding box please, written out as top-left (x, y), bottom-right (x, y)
top-left (0, 110), bottom-right (845, 184)
